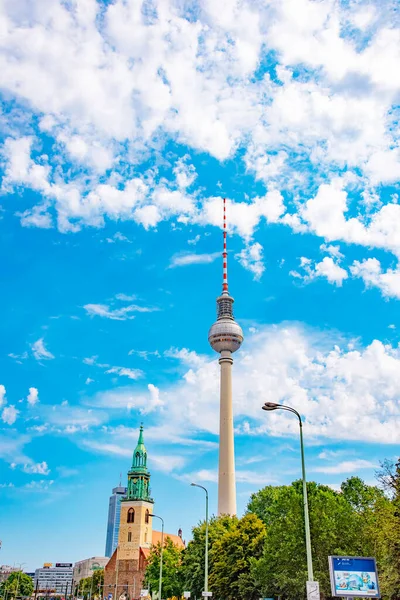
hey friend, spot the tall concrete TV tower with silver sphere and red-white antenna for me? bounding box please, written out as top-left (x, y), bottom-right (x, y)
top-left (208, 198), bottom-right (243, 515)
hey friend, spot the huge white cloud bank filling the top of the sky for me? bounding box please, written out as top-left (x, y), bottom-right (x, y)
top-left (0, 0), bottom-right (400, 262)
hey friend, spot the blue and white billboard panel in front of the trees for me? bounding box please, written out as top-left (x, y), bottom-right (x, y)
top-left (329, 556), bottom-right (381, 598)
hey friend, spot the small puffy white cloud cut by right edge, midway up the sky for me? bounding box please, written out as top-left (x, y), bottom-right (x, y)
top-left (350, 258), bottom-right (400, 299)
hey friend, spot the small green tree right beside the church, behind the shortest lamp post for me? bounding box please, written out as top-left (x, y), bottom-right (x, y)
top-left (145, 537), bottom-right (183, 598)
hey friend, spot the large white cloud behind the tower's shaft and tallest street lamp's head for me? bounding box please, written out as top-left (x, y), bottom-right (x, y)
top-left (91, 325), bottom-right (400, 444)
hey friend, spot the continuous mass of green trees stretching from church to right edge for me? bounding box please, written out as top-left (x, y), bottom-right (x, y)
top-left (146, 468), bottom-right (400, 600)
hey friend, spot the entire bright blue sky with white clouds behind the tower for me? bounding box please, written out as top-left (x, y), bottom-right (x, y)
top-left (0, 0), bottom-right (400, 569)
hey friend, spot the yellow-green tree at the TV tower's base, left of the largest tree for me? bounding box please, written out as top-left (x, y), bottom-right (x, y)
top-left (210, 514), bottom-right (265, 600)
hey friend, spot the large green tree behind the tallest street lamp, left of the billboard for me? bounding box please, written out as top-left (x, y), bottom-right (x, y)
top-left (248, 481), bottom-right (380, 600)
